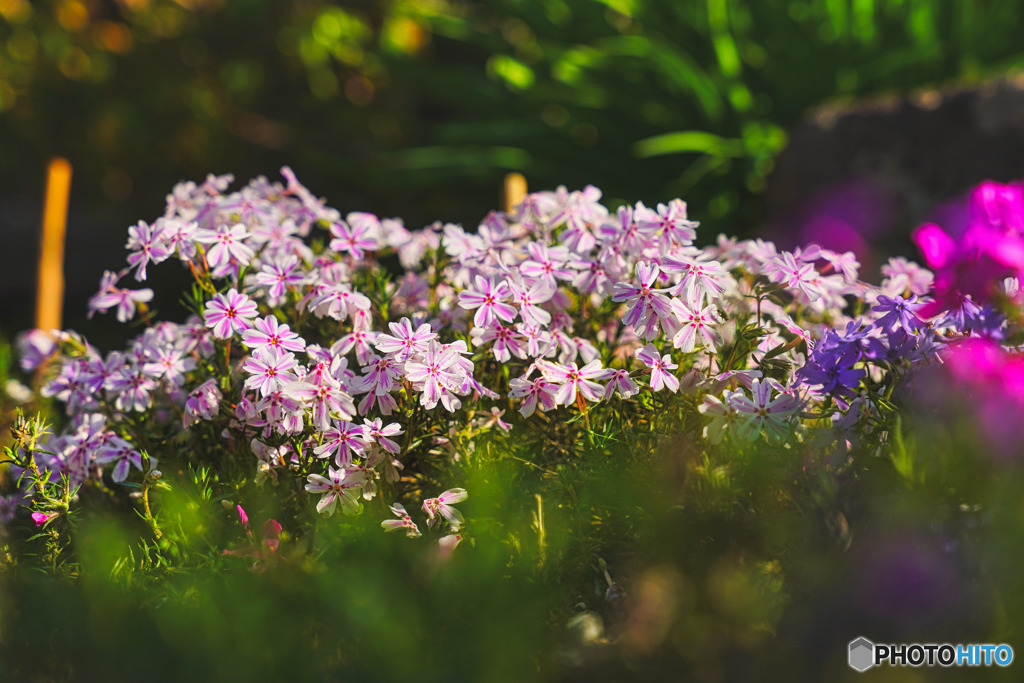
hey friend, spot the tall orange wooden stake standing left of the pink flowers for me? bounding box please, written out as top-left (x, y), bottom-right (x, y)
top-left (36, 157), bottom-right (71, 330)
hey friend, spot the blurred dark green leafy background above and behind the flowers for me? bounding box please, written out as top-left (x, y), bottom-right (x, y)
top-left (6, 0), bottom-right (1024, 332)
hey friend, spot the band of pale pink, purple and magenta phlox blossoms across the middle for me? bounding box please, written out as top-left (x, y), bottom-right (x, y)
top-left (12, 168), bottom-right (1024, 548)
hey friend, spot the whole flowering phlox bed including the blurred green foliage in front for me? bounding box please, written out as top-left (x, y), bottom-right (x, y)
top-left (0, 168), bottom-right (1024, 680)
